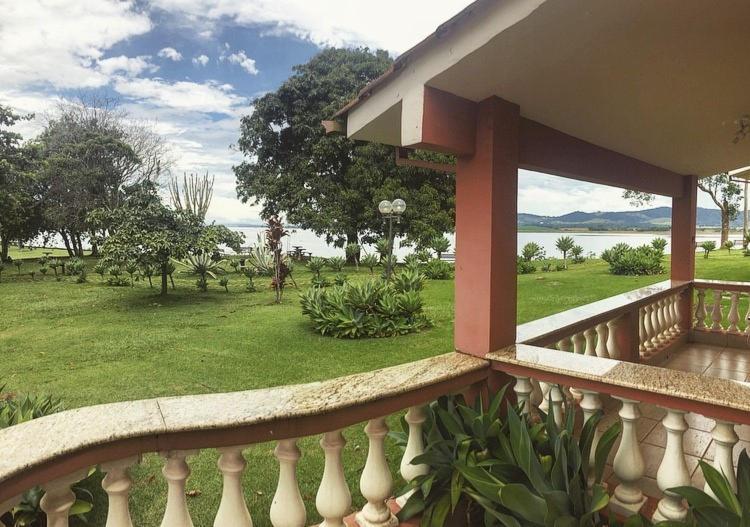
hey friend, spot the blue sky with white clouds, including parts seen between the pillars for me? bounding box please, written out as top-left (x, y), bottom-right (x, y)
top-left (0, 0), bottom-right (712, 224)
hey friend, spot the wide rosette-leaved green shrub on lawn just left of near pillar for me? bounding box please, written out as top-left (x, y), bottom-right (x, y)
top-left (300, 273), bottom-right (432, 339)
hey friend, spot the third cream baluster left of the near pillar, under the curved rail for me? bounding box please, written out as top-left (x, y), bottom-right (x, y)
top-left (315, 430), bottom-right (352, 527)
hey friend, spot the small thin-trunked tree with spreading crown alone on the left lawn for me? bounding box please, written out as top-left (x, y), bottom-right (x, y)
top-left (97, 181), bottom-right (207, 295)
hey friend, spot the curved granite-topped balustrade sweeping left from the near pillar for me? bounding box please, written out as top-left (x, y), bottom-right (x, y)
top-left (0, 353), bottom-right (488, 527)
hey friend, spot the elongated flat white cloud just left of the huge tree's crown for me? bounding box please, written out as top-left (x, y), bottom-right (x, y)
top-left (113, 77), bottom-right (247, 116)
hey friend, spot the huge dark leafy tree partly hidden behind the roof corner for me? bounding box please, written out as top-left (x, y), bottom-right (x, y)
top-left (234, 49), bottom-right (455, 253)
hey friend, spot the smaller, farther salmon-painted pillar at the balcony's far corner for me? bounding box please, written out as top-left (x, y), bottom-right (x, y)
top-left (671, 176), bottom-right (698, 331)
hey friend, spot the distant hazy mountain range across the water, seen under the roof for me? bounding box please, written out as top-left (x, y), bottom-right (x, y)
top-left (518, 207), bottom-right (742, 230)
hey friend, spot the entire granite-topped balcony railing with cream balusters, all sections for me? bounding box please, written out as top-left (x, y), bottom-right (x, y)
top-left (0, 281), bottom-right (750, 527)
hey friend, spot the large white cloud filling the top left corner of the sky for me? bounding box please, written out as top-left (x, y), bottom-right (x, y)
top-left (0, 0), bottom-right (151, 89)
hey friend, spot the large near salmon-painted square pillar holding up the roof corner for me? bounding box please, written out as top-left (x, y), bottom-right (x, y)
top-left (455, 97), bottom-right (520, 356)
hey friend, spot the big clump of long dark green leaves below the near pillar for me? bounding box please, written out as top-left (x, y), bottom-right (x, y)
top-left (397, 388), bottom-right (620, 527)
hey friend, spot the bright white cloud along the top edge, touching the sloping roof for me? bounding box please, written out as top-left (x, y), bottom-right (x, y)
top-left (152, 0), bottom-right (471, 53)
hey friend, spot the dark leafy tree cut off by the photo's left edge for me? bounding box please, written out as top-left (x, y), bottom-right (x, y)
top-left (0, 105), bottom-right (43, 262)
